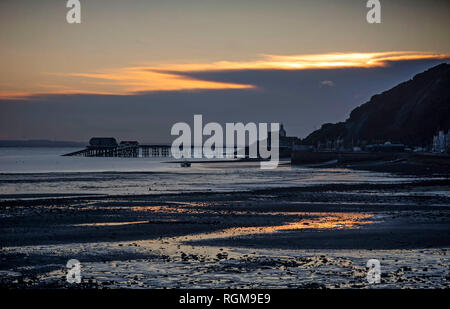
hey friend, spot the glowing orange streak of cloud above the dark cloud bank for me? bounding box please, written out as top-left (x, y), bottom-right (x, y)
top-left (0, 51), bottom-right (450, 99)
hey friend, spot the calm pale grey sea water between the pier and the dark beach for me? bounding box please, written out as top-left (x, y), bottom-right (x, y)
top-left (0, 148), bottom-right (412, 198)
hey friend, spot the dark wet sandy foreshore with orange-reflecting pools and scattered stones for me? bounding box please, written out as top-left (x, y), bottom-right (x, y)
top-left (0, 178), bottom-right (450, 288)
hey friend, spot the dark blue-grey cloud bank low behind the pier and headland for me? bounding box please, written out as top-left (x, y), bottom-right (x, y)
top-left (0, 60), bottom-right (443, 142)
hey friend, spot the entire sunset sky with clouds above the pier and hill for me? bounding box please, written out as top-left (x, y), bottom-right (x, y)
top-left (0, 0), bottom-right (450, 142)
